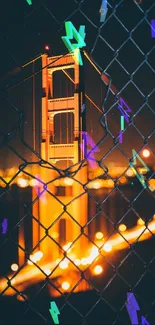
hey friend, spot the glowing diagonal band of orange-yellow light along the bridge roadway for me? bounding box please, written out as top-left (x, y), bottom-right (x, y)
top-left (0, 219), bottom-right (155, 296)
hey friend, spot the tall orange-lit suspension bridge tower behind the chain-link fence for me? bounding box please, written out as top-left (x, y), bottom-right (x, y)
top-left (33, 53), bottom-right (88, 261)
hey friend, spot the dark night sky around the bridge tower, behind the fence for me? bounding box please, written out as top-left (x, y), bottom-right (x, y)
top-left (0, 0), bottom-right (155, 169)
